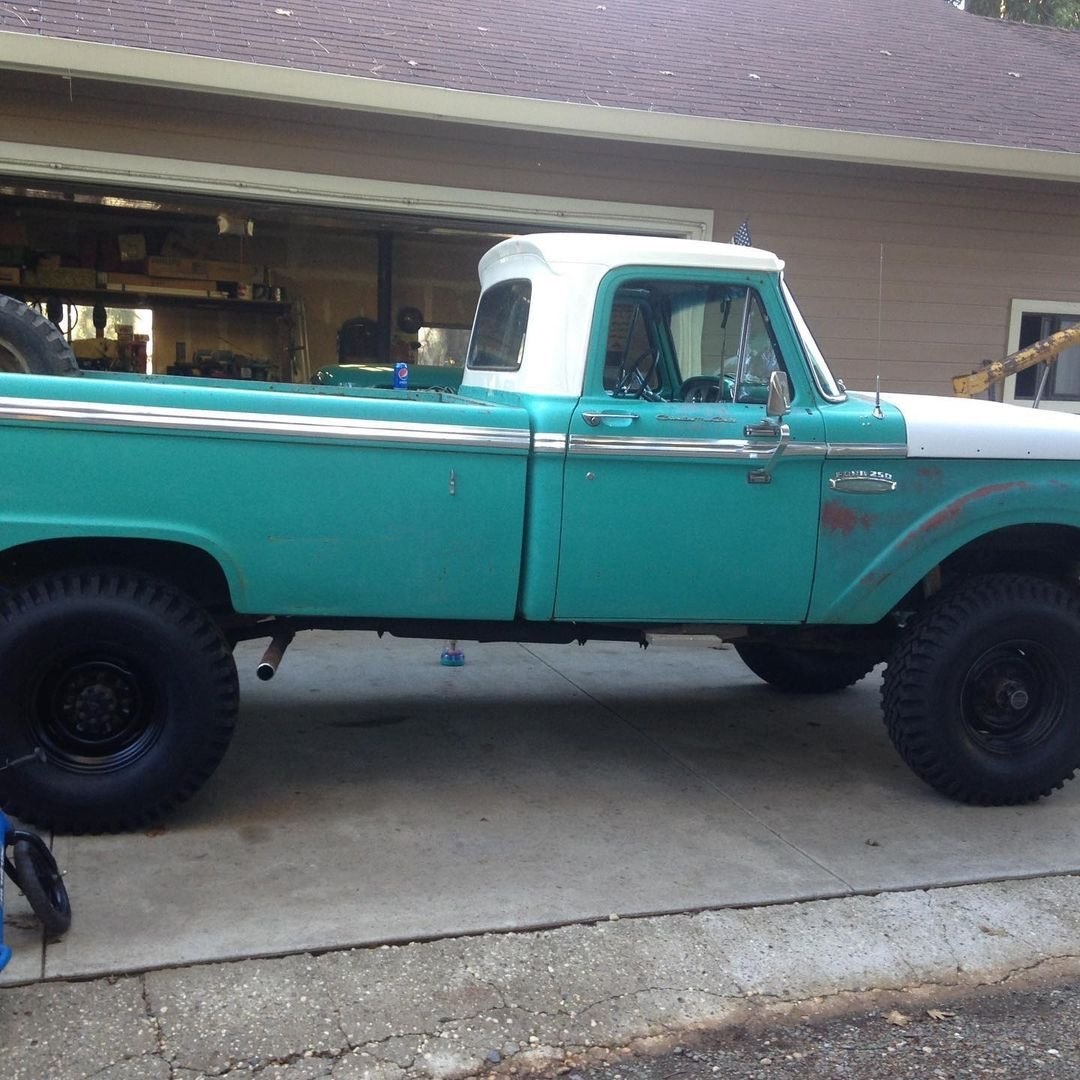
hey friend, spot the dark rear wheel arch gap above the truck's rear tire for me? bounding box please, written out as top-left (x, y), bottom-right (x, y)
top-left (0, 536), bottom-right (234, 611)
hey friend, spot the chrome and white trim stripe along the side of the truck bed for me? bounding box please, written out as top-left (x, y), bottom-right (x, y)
top-left (0, 397), bottom-right (530, 450)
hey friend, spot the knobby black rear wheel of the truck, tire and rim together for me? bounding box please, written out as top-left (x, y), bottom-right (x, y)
top-left (0, 569), bottom-right (239, 833)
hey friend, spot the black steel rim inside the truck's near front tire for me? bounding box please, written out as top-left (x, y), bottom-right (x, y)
top-left (960, 640), bottom-right (1066, 756)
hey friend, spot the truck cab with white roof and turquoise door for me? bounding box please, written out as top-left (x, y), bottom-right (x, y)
top-left (461, 235), bottom-right (876, 624)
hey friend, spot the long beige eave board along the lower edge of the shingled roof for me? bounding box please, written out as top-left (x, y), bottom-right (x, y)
top-left (0, 31), bottom-right (1080, 183)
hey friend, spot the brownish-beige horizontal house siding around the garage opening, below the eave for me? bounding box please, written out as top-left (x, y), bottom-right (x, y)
top-left (0, 72), bottom-right (1080, 393)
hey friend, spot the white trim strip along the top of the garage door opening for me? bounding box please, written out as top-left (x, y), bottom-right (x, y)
top-left (0, 140), bottom-right (713, 240)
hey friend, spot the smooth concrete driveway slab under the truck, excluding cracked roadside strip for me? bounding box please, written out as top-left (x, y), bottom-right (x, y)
top-left (0, 633), bottom-right (1080, 983)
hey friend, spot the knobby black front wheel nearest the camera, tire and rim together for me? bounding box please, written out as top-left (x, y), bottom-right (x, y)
top-left (882, 573), bottom-right (1080, 806)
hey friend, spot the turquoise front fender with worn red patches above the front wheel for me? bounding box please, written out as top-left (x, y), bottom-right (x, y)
top-left (809, 459), bottom-right (1080, 624)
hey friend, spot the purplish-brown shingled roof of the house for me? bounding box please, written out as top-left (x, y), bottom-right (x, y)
top-left (0, 0), bottom-right (1080, 153)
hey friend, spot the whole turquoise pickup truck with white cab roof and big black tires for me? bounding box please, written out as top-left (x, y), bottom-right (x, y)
top-left (0, 234), bottom-right (1080, 832)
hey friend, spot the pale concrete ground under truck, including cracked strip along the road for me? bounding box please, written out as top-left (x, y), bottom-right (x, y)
top-left (0, 634), bottom-right (1080, 1080)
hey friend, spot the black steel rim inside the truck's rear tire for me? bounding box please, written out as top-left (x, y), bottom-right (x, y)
top-left (30, 656), bottom-right (162, 772)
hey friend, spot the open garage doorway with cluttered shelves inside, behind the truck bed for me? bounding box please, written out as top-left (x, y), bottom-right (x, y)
top-left (0, 145), bottom-right (712, 382)
